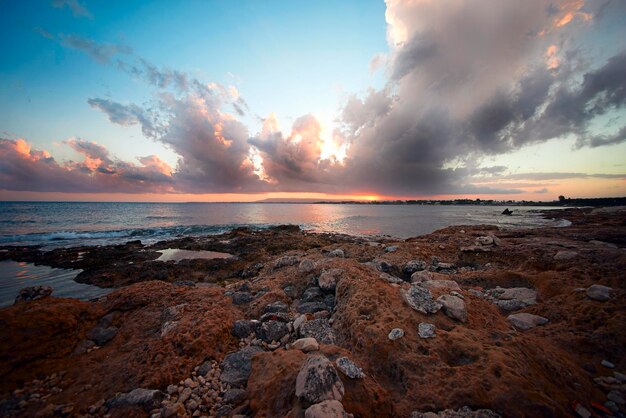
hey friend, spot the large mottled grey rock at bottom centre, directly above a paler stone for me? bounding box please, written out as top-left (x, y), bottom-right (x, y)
top-left (296, 354), bottom-right (344, 404)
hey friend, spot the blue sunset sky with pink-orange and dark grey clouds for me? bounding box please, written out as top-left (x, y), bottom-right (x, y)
top-left (0, 0), bottom-right (626, 201)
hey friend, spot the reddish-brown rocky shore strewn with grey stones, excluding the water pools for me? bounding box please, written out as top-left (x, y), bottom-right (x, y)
top-left (0, 209), bottom-right (626, 418)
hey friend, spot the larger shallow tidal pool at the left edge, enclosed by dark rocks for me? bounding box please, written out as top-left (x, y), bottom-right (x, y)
top-left (0, 261), bottom-right (112, 307)
